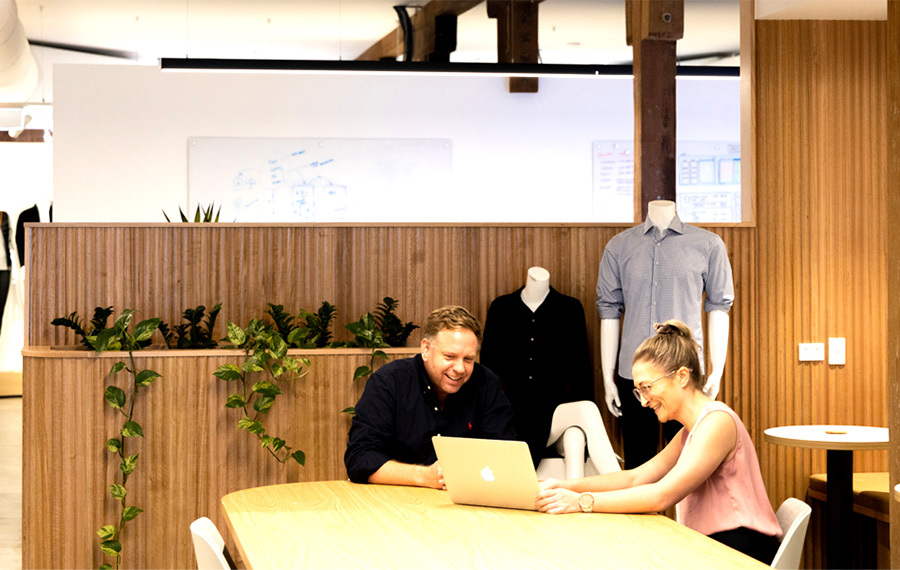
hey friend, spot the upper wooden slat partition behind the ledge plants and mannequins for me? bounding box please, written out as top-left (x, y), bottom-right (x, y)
top-left (26, 224), bottom-right (756, 440)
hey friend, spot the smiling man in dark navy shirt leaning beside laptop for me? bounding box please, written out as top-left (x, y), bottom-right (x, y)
top-left (344, 306), bottom-right (515, 489)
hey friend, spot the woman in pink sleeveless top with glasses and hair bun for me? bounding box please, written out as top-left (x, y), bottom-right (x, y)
top-left (535, 320), bottom-right (782, 564)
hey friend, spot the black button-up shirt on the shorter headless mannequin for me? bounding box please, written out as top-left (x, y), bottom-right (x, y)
top-left (480, 287), bottom-right (594, 466)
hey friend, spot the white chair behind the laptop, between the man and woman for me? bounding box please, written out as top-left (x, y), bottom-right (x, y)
top-left (537, 400), bottom-right (622, 479)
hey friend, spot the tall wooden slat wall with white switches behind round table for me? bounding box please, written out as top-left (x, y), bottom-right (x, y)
top-left (745, 21), bottom-right (888, 567)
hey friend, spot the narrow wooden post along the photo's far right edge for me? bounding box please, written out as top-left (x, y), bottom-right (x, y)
top-left (885, 2), bottom-right (900, 568)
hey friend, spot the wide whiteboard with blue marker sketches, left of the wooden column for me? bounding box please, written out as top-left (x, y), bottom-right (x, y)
top-left (188, 137), bottom-right (453, 223)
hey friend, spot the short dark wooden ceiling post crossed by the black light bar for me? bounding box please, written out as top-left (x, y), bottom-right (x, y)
top-left (488, 0), bottom-right (541, 93)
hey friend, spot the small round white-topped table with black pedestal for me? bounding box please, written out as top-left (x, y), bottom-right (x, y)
top-left (764, 425), bottom-right (890, 568)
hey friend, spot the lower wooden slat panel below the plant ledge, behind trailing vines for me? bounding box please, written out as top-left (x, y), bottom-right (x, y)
top-left (22, 349), bottom-right (412, 568)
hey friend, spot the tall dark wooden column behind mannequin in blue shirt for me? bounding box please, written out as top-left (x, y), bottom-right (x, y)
top-left (625, 0), bottom-right (684, 219)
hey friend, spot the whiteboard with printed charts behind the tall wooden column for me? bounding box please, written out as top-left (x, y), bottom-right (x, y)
top-left (593, 140), bottom-right (741, 223)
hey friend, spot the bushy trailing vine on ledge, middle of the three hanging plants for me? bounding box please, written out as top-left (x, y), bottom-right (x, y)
top-left (213, 319), bottom-right (309, 465)
